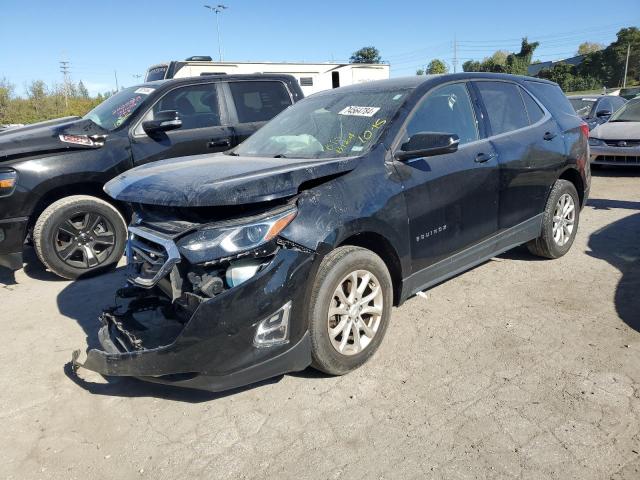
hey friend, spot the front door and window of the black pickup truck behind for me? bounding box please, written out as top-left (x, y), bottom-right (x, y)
top-left (131, 83), bottom-right (235, 165)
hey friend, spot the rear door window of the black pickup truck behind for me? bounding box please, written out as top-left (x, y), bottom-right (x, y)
top-left (229, 81), bottom-right (292, 123)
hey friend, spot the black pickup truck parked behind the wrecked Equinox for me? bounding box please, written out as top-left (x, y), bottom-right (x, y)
top-left (0, 75), bottom-right (303, 279)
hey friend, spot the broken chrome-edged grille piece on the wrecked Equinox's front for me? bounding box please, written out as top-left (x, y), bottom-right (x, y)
top-left (127, 227), bottom-right (180, 288)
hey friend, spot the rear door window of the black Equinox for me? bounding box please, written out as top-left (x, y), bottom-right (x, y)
top-left (476, 82), bottom-right (529, 135)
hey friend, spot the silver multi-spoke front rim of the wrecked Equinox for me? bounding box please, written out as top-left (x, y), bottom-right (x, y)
top-left (328, 270), bottom-right (384, 355)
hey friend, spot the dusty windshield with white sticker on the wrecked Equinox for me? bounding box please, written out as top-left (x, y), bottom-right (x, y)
top-left (234, 89), bottom-right (409, 158)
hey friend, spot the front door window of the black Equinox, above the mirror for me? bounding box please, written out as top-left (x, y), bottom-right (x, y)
top-left (407, 83), bottom-right (480, 145)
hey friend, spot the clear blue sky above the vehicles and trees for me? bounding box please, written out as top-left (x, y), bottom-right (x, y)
top-left (0, 0), bottom-right (640, 94)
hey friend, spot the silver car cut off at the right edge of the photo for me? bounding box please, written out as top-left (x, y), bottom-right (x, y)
top-left (589, 98), bottom-right (640, 167)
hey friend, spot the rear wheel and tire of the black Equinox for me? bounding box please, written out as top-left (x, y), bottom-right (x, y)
top-left (527, 180), bottom-right (580, 258)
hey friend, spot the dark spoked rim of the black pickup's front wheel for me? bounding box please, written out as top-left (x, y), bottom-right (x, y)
top-left (54, 212), bottom-right (116, 269)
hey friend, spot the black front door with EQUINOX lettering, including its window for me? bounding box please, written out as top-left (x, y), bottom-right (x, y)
top-left (395, 83), bottom-right (499, 272)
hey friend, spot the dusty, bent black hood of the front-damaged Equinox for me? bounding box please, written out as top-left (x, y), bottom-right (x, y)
top-left (104, 154), bottom-right (359, 207)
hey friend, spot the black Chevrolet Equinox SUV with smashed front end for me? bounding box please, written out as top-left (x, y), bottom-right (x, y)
top-left (73, 73), bottom-right (590, 390)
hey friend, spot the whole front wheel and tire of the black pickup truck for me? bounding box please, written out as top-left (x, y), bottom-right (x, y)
top-left (33, 195), bottom-right (127, 280)
